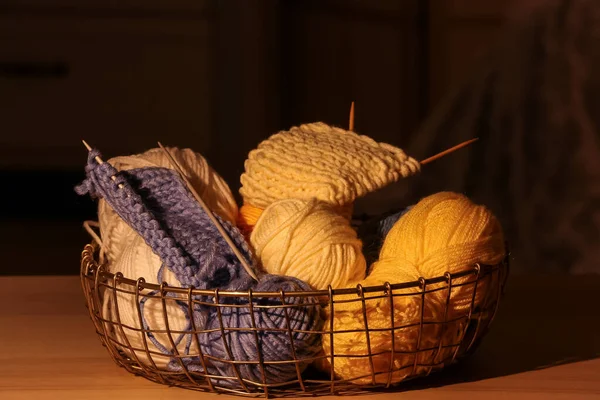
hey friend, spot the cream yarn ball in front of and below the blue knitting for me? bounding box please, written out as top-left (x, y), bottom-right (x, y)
top-left (103, 232), bottom-right (197, 368)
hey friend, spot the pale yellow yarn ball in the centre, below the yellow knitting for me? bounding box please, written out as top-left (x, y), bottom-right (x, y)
top-left (250, 199), bottom-right (366, 289)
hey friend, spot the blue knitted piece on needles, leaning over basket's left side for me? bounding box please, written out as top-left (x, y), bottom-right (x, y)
top-left (76, 150), bottom-right (253, 290)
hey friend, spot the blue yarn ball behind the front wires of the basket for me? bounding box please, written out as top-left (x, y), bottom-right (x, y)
top-left (173, 275), bottom-right (323, 387)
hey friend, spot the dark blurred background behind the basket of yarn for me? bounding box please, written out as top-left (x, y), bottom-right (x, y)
top-left (0, 0), bottom-right (600, 275)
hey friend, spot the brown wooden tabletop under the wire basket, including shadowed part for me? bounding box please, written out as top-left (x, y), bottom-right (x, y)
top-left (0, 276), bottom-right (600, 400)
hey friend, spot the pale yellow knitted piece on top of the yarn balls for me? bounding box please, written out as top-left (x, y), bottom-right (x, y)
top-left (240, 122), bottom-right (420, 208)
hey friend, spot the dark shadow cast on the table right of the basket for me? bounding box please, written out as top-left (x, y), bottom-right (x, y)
top-left (401, 275), bottom-right (600, 390)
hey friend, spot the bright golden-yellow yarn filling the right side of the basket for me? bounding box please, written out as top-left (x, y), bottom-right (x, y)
top-left (323, 192), bottom-right (505, 383)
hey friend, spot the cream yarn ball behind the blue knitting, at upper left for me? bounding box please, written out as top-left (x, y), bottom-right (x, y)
top-left (98, 147), bottom-right (238, 260)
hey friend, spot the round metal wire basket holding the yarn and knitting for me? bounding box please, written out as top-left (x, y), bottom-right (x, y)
top-left (81, 244), bottom-right (509, 397)
